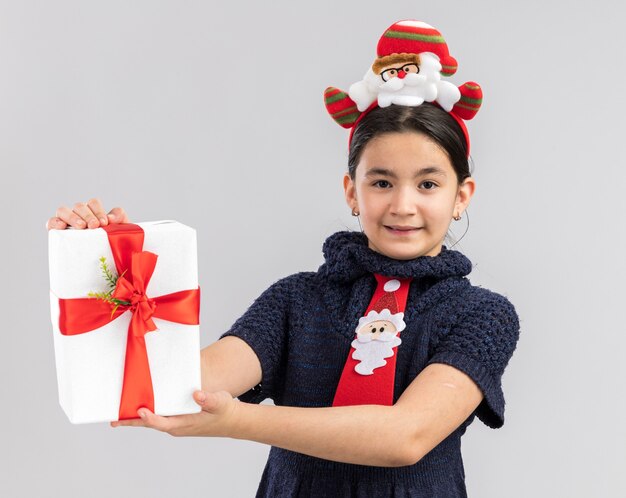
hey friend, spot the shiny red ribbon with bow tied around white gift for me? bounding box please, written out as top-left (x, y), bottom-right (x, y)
top-left (59, 223), bottom-right (200, 420)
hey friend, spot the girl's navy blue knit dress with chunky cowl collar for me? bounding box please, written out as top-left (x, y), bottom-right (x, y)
top-left (217, 232), bottom-right (519, 498)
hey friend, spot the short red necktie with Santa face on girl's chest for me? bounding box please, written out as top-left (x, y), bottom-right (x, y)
top-left (332, 273), bottom-right (412, 406)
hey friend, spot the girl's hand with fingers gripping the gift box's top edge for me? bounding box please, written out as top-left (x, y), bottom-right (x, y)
top-left (46, 199), bottom-right (129, 230)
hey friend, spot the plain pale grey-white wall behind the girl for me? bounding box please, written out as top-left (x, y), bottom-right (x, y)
top-left (0, 0), bottom-right (626, 498)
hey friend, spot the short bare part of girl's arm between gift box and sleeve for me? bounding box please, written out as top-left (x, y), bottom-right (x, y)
top-left (200, 336), bottom-right (261, 398)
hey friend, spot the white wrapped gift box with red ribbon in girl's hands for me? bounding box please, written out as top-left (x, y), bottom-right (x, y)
top-left (48, 221), bottom-right (201, 424)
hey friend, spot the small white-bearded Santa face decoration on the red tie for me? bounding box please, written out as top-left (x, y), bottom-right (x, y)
top-left (351, 309), bottom-right (406, 375)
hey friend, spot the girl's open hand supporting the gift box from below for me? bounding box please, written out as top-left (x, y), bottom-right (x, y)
top-left (111, 391), bottom-right (240, 437)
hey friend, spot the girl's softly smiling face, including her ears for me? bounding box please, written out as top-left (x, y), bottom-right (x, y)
top-left (344, 132), bottom-right (475, 260)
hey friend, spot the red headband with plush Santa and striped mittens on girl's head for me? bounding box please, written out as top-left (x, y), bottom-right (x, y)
top-left (324, 19), bottom-right (483, 156)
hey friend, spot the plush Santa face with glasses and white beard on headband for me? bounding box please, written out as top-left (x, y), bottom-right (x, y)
top-left (348, 52), bottom-right (461, 112)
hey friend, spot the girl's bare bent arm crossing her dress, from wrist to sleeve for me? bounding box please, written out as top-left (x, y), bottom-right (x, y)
top-left (229, 364), bottom-right (482, 467)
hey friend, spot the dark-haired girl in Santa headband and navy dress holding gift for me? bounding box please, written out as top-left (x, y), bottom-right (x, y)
top-left (48, 21), bottom-right (519, 498)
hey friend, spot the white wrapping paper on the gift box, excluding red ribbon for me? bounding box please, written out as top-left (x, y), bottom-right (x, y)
top-left (48, 221), bottom-right (201, 424)
